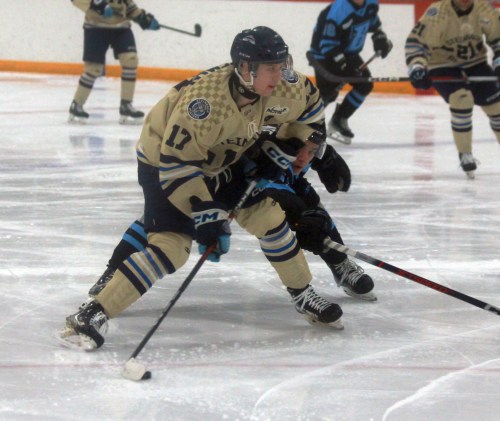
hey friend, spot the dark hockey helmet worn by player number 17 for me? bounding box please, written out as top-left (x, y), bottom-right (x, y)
top-left (231, 26), bottom-right (289, 68)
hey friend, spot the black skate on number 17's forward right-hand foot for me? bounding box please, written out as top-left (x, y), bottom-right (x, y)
top-left (287, 285), bottom-right (344, 329)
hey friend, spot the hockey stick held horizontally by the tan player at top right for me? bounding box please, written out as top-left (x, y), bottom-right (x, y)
top-left (306, 51), bottom-right (499, 83)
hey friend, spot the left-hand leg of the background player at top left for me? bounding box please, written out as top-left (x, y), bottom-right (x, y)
top-left (68, 28), bottom-right (109, 122)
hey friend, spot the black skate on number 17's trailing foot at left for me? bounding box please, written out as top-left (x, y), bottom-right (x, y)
top-left (56, 300), bottom-right (108, 351)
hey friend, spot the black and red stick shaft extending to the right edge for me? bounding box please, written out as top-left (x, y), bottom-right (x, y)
top-left (324, 238), bottom-right (500, 316)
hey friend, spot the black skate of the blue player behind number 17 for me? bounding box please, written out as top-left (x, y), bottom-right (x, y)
top-left (329, 257), bottom-right (377, 301)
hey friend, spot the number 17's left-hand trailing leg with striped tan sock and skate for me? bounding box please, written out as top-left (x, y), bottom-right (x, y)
top-left (58, 163), bottom-right (193, 350)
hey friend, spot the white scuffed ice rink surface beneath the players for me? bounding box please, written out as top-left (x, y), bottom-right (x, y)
top-left (0, 73), bottom-right (500, 421)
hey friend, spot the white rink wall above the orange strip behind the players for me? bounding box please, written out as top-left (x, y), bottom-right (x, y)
top-left (0, 0), bottom-right (414, 76)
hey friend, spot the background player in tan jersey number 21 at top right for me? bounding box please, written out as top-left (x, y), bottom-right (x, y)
top-left (405, 0), bottom-right (500, 178)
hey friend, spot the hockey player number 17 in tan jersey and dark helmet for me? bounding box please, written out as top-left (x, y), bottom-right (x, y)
top-left (55, 27), bottom-right (343, 350)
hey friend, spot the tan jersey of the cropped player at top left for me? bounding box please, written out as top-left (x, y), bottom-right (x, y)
top-left (71, 0), bottom-right (142, 29)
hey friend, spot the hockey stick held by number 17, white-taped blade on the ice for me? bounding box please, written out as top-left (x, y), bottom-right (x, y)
top-left (122, 180), bottom-right (258, 381)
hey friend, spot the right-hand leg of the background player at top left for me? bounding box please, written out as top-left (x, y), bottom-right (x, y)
top-left (112, 28), bottom-right (144, 124)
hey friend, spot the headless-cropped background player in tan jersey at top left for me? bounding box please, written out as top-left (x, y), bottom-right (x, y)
top-left (69, 0), bottom-right (160, 124)
